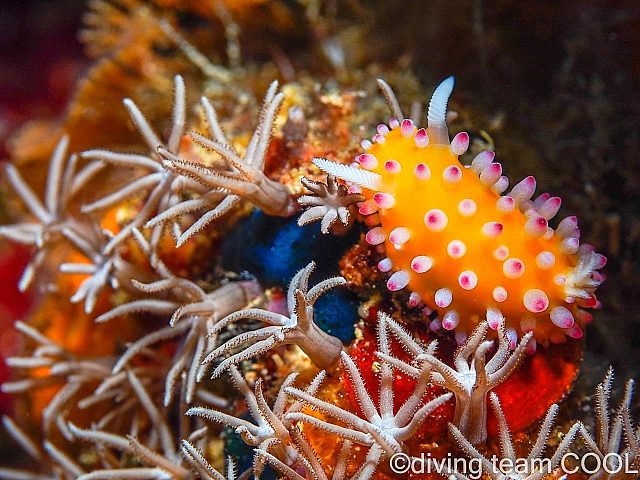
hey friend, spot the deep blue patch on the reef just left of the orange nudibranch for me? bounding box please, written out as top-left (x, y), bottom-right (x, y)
top-left (221, 210), bottom-right (361, 344)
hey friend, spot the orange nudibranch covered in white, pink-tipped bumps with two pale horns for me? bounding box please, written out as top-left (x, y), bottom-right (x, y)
top-left (314, 77), bottom-right (606, 351)
